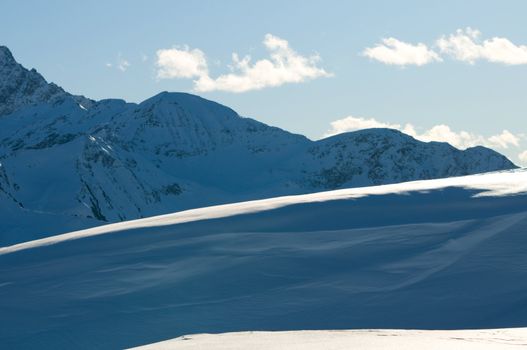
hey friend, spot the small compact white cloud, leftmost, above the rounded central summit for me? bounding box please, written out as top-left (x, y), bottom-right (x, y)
top-left (156, 46), bottom-right (209, 79)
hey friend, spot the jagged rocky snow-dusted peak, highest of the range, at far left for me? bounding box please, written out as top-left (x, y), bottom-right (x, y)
top-left (0, 46), bottom-right (67, 117)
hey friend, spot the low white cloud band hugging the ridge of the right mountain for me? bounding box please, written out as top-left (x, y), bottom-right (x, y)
top-left (324, 116), bottom-right (520, 149)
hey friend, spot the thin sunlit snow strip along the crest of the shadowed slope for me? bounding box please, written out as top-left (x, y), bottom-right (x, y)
top-left (0, 169), bottom-right (527, 254)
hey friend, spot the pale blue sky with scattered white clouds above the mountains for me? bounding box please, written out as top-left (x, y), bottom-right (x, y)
top-left (0, 0), bottom-right (527, 165)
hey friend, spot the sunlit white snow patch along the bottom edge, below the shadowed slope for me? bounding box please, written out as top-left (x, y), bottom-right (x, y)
top-left (135, 328), bottom-right (527, 350)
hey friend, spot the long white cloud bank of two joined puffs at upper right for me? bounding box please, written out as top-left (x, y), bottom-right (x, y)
top-left (362, 27), bottom-right (527, 66)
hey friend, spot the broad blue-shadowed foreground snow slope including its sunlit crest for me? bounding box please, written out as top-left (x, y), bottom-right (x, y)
top-left (0, 170), bottom-right (527, 349)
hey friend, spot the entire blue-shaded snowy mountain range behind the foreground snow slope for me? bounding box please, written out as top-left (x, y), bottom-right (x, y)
top-left (0, 47), bottom-right (515, 245)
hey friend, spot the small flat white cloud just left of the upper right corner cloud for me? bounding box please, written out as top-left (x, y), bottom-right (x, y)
top-left (362, 38), bottom-right (442, 66)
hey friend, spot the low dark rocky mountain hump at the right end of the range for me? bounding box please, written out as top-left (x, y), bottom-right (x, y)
top-left (309, 129), bottom-right (514, 189)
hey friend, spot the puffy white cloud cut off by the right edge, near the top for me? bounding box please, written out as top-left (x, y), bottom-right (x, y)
top-left (437, 28), bottom-right (527, 65)
